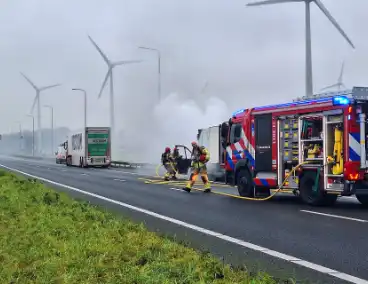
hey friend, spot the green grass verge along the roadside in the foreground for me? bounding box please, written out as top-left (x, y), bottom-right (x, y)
top-left (0, 171), bottom-right (284, 284)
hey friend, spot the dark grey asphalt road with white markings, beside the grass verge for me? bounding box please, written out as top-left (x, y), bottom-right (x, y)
top-left (0, 157), bottom-right (368, 283)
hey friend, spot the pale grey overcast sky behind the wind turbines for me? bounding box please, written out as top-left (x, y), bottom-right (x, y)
top-left (0, 0), bottom-right (368, 137)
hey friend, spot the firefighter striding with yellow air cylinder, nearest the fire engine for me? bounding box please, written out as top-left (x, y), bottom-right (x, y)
top-left (183, 142), bottom-right (211, 192)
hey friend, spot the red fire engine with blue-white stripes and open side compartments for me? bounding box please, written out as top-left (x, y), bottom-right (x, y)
top-left (221, 87), bottom-right (368, 205)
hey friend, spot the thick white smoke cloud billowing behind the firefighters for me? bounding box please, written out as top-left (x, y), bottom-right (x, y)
top-left (117, 93), bottom-right (230, 163)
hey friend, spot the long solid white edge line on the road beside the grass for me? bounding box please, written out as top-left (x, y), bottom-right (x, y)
top-left (0, 164), bottom-right (368, 284)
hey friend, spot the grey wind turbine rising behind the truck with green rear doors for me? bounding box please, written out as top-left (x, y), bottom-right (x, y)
top-left (88, 36), bottom-right (143, 134)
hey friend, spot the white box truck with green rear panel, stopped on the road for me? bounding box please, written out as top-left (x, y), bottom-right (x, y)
top-left (65, 127), bottom-right (111, 167)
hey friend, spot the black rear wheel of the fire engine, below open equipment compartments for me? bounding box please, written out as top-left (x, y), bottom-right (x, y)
top-left (300, 171), bottom-right (337, 206)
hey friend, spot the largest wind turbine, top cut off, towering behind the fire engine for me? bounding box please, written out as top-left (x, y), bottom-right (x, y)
top-left (247, 0), bottom-right (355, 97)
